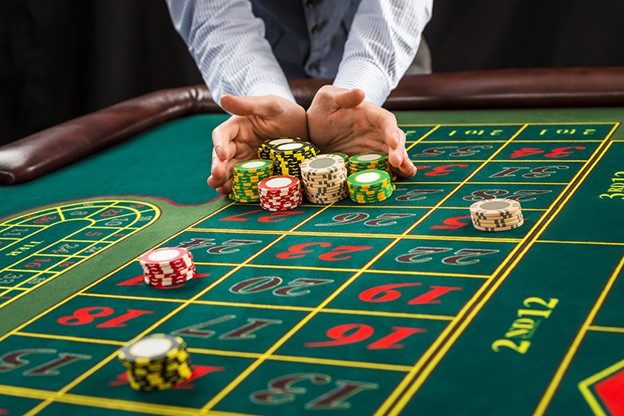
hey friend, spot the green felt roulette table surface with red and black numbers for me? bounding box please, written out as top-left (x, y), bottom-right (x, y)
top-left (0, 73), bottom-right (624, 415)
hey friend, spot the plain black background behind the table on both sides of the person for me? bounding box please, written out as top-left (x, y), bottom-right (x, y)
top-left (0, 0), bottom-right (624, 144)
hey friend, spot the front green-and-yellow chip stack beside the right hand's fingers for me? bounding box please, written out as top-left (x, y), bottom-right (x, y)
top-left (347, 169), bottom-right (394, 204)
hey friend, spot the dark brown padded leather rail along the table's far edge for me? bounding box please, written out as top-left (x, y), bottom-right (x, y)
top-left (0, 68), bottom-right (624, 184)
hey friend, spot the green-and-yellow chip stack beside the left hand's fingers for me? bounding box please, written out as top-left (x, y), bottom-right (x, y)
top-left (229, 159), bottom-right (273, 202)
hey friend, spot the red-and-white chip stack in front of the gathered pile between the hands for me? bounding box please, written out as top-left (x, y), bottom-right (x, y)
top-left (258, 175), bottom-right (303, 211)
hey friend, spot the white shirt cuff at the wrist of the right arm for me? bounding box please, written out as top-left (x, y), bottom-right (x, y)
top-left (334, 61), bottom-right (390, 106)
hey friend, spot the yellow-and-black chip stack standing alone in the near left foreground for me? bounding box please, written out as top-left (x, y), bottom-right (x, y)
top-left (117, 334), bottom-right (193, 391)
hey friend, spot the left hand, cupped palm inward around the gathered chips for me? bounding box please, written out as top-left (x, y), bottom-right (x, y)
top-left (208, 95), bottom-right (308, 194)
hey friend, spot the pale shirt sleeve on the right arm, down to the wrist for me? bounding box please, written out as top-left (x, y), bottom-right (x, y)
top-left (334, 0), bottom-right (433, 105)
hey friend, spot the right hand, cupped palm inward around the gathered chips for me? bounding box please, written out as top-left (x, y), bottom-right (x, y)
top-left (308, 85), bottom-right (416, 178)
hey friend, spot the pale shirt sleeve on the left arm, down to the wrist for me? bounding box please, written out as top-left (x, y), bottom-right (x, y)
top-left (166, 0), bottom-right (295, 103)
